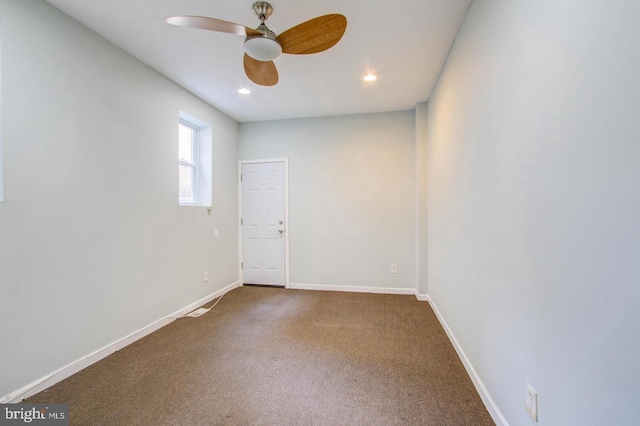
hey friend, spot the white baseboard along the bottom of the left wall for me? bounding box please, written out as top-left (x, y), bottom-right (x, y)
top-left (0, 282), bottom-right (242, 404)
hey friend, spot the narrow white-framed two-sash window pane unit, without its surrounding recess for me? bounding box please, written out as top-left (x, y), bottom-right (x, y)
top-left (178, 120), bottom-right (200, 204)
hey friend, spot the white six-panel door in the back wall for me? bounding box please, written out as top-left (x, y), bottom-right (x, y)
top-left (241, 162), bottom-right (286, 286)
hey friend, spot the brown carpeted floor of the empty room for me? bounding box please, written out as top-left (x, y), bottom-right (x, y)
top-left (27, 287), bottom-right (494, 426)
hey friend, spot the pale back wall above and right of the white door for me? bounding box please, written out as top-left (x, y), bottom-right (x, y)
top-left (239, 111), bottom-right (415, 289)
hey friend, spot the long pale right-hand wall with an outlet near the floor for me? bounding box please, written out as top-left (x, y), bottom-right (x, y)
top-left (428, 0), bottom-right (640, 426)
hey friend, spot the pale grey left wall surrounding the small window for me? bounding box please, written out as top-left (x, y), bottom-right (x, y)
top-left (0, 0), bottom-right (238, 397)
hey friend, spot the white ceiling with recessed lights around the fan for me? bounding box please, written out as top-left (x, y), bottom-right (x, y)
top-left (47, 0), bottom-right (471, 122)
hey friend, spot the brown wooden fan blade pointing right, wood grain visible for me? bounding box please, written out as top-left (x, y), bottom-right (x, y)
top-left (278, 14), bottom-right (347, 55)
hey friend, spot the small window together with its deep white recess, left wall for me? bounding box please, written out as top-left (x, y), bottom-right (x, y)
top-left (178, 112), bottom-right (212, 207)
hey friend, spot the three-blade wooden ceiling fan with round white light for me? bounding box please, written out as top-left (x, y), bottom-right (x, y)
top-left (165, 1), bottom-right (347, 86)
